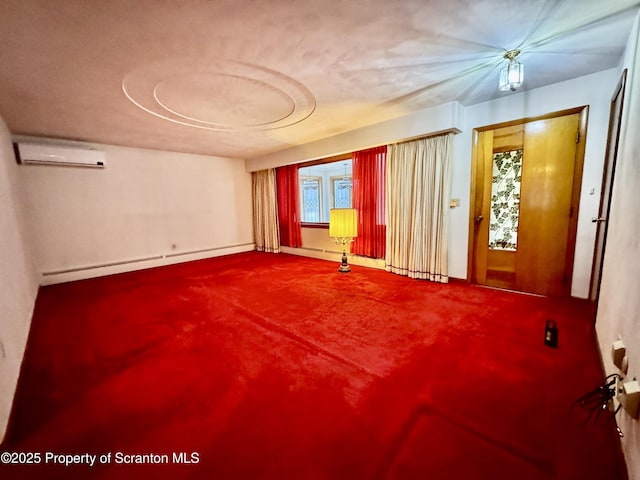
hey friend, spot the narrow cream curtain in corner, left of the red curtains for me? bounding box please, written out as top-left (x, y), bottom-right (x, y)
top-left (251, 168), bottom-right (280, 253)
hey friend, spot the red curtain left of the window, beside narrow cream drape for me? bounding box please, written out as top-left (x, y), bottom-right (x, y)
top-left (276, 165), bottom-right (302, 247)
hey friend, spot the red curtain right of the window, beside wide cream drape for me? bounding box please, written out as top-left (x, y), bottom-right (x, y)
top-left (351, 146), bottom-right (387, 258)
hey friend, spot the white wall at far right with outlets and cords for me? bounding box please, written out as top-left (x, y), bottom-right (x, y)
top-left (596, 12), bottom-right (640, 480)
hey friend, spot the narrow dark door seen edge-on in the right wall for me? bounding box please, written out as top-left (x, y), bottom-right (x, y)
top-left (589, 70), bottom-right (627, 312)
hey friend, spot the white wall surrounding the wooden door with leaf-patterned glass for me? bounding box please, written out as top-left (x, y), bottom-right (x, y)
top-left (449, 69), bottom-right (618, 298)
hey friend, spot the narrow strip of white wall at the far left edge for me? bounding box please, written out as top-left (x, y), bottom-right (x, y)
top-left (0, 114), bottom-right (38, 440)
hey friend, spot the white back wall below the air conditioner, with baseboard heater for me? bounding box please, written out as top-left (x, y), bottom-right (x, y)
top-left (19, 138), bottom-right (254, 284)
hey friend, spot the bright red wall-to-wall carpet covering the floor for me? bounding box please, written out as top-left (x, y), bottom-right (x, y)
top-left (0, 253), bottom-right (626, 480)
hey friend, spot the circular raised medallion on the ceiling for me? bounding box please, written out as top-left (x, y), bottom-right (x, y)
top-left (122, 57), bottom-right (316, 131)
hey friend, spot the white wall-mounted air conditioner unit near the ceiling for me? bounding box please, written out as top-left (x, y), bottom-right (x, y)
top-left (16, 143), bottom-right (105, 168)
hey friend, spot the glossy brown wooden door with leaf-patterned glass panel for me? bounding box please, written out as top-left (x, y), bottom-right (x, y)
top-left (470, 110), bottom-right (586, 295)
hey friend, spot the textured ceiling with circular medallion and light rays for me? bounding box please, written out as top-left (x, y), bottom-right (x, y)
top-left (0, 0), bottom-right (639, 158)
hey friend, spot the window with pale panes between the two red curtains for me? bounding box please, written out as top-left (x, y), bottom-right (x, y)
top-left (298, 158), bottom-right (353, 223)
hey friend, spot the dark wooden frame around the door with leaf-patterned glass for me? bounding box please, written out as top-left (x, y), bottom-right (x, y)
top-left (467, 105), bottom-right (589, 296)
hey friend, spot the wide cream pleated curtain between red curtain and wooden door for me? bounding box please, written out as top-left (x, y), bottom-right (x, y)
top-left (385, 134), bottom-right (453, 283)
